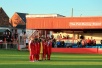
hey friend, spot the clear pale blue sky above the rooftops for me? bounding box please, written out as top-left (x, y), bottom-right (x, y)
top-left (0, 0), bottom-right (102, 18)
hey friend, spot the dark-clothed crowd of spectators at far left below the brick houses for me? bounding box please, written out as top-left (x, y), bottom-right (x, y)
top-left (0, 29), bottom-right (18, 48)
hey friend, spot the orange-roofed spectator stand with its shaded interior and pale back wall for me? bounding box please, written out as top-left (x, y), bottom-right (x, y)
top-left (26, 16), bottom-right (102, 47)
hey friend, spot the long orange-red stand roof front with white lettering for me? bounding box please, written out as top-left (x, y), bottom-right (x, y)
top-left (26, 17), bottom-right (102, 29)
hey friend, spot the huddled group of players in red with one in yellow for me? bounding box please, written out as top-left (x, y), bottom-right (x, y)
top-left (28, 38), bottom-right (52, 62)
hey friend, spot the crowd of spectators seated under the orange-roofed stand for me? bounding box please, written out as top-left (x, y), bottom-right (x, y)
top-left (52, 37), bottom-right (102, 48)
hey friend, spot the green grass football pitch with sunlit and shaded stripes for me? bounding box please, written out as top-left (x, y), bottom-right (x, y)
top-left (0, 49), bottom-right (102, 68)
